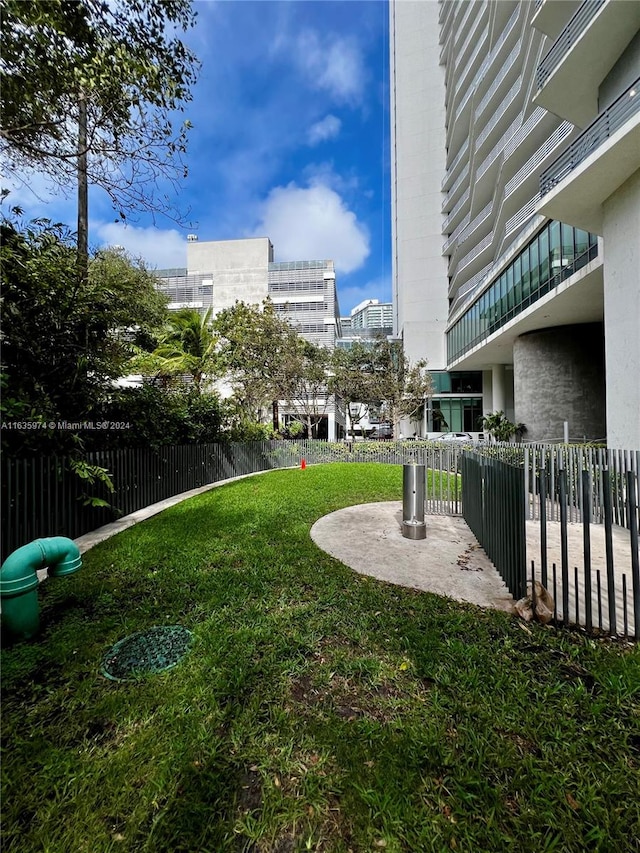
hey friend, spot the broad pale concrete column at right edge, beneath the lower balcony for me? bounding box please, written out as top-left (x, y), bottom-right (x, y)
top-left (603, 170), bottom-right (640, 450)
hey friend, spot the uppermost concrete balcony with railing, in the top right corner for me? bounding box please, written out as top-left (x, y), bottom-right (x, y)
top-left (533, 0), bottom-right (640, 128)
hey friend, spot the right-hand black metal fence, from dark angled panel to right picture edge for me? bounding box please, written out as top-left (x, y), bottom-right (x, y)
top-left (472, 444), bottom-right (640, 638)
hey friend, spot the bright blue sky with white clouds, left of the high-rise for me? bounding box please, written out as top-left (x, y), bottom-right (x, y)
top-left (7, 0), bottom-right (391, 314)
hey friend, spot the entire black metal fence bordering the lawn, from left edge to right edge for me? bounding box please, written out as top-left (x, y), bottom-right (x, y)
top-left (0, 440), bottom-right (640, 637)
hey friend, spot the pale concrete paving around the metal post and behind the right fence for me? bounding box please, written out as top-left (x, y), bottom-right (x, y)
top-left (311, 501), bottom-right (633, 632)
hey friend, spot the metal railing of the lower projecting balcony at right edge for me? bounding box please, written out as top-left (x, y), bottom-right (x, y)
top-left (540, 77), bottom-right (640, 195)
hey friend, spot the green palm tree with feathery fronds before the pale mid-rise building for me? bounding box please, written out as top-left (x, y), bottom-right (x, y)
top-left (153, 308), bottom-right (218, 393)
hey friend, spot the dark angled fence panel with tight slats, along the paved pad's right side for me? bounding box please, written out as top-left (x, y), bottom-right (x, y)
top-left (462, 452), bottom-right (527, 599)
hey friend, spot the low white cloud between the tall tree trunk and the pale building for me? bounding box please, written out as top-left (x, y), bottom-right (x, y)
top-left (91, 222), bottom-right (187, 269)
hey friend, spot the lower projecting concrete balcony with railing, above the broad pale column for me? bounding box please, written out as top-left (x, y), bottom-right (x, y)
top-left (537, 78), bottom-right (640, 234)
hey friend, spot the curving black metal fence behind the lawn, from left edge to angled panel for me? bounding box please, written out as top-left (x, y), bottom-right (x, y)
top-left (0, 440), bottom-right (462, 560)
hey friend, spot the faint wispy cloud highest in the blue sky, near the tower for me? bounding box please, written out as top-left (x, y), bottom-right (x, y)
top-left (296, 30), bottom-right (366, 106)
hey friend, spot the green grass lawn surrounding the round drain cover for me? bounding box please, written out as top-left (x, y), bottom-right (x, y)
top-left (2, 464), bottom-right (640, 853)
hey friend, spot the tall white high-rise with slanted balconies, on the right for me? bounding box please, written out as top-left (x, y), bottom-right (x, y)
top-left (390, 0), bottom-right (640, 449)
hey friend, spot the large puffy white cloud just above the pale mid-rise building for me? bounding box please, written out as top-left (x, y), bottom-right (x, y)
top-left (254, 182), bottom-right (370, 273)
